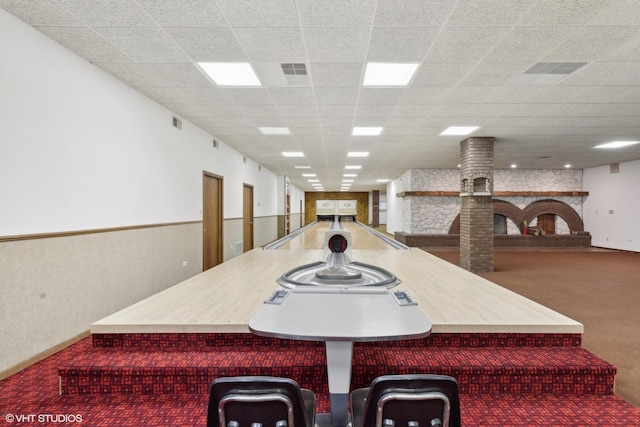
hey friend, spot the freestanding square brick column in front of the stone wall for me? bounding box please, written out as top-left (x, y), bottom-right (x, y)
top-left (460, 137), bottom-right (493, 273)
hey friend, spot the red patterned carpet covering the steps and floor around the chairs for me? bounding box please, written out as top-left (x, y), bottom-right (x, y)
top-left (0, 336), bottom-right (640, 427)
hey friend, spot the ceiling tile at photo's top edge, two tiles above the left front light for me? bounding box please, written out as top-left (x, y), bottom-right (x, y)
top-left (136, 0), bottom-right (226, 27)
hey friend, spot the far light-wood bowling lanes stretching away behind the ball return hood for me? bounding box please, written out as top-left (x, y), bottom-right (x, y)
top-left (278, 221), bottom-right (394, 250)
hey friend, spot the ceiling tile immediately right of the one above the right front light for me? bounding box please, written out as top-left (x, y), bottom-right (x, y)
top-left (426, 26), bottom-right (510, 62)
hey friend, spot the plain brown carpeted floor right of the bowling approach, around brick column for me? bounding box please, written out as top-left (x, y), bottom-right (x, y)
top-left (421, 248), bottom-right (640, 407)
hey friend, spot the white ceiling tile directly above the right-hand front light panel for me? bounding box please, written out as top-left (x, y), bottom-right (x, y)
top-left (367, 27), bottom-right (439, 62)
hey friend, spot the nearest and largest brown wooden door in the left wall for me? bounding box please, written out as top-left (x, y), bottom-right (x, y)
top-left (202, 172), bottom-right (224, 271)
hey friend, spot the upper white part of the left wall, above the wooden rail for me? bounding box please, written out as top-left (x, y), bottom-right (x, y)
top-left (0, 10), bottom-right (277, 236)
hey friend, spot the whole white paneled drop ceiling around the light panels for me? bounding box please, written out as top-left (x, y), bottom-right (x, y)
top-left (0, 0), bottom-right (640, 191)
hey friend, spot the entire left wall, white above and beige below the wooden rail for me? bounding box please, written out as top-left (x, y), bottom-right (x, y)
top-left (0, 10), bottom-right (277, 371)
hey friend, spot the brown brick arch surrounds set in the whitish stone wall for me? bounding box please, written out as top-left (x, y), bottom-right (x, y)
top-left (449, 199), bottom-right (584, 234)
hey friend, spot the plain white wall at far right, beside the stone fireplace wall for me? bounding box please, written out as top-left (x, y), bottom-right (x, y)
top-left (583, 160), bottom-right (640, 252)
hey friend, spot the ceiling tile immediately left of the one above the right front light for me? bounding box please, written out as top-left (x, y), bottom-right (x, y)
top-left (302, 27), bottom-right (370, 62)
